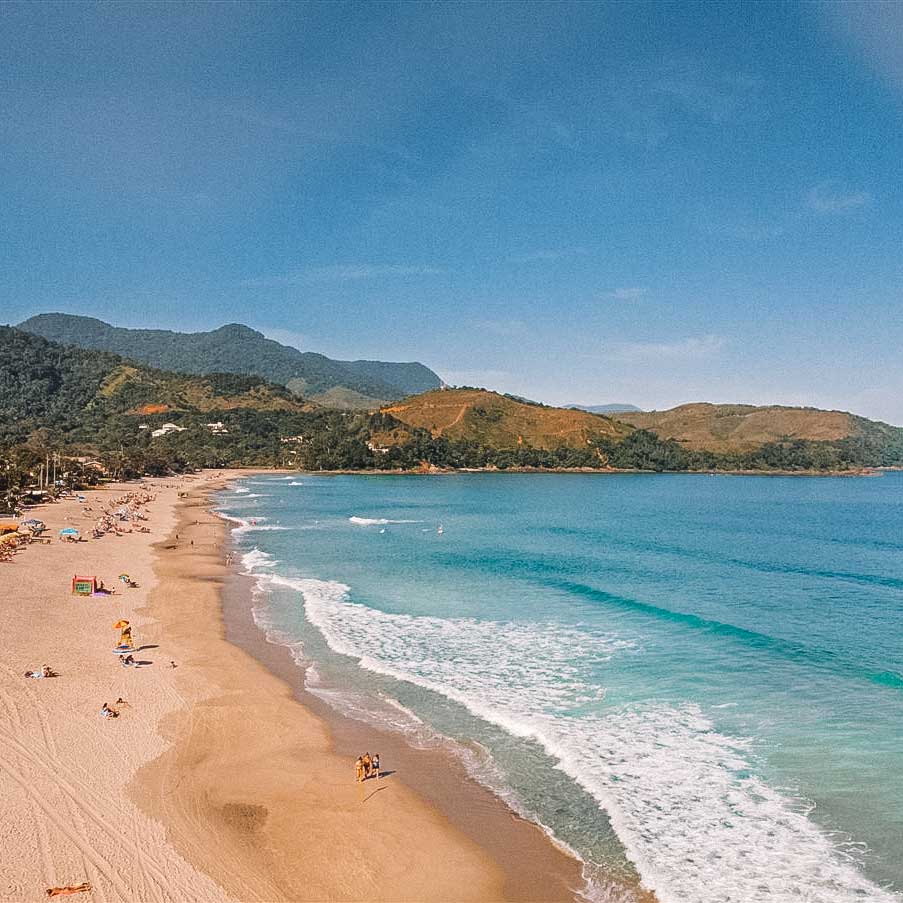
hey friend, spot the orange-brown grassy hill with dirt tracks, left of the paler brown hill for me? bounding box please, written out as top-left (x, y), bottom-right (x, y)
top-left (383, 389), bottom-right (633, 450)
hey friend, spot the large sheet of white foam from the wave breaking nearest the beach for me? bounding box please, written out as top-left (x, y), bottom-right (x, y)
top-left (267, 575), bottom-right (899, 903)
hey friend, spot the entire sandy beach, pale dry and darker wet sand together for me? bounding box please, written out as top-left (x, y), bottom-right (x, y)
top-left (0, 472), bottom-right (580, 901)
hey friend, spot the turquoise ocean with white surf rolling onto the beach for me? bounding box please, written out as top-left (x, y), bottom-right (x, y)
top-left (218, 473), bottom-right (903, 903)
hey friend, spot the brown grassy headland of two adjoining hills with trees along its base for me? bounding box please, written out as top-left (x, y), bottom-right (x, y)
top-left (382, 389), bottom-right (903, 472)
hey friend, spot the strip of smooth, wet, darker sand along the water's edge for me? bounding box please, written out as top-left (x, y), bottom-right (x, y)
top-left (130, 472), bottom-right (583, 901)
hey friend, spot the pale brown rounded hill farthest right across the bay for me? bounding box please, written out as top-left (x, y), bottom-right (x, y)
top-left (617, 403), bottom-right (903, 453)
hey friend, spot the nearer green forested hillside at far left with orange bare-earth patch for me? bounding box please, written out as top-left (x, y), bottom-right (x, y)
top-left (0, 327), bottom-right (315, 461)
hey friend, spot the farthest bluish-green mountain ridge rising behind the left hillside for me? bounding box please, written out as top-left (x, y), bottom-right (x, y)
top-left (18, 314), bottom-right (441, 409)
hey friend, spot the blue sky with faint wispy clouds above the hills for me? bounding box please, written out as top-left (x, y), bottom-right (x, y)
top-left (0, 2), bottom-right (903, 424)
